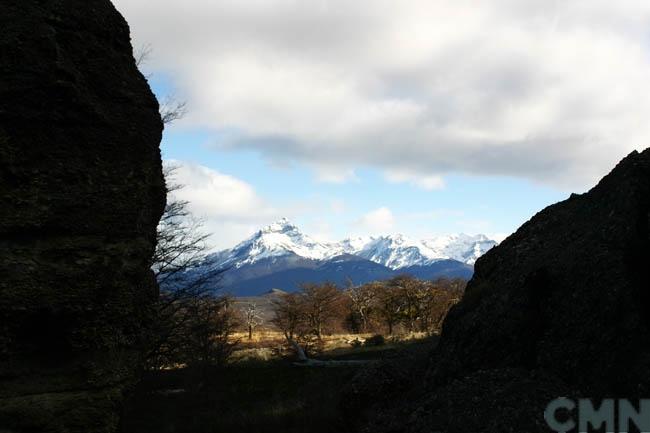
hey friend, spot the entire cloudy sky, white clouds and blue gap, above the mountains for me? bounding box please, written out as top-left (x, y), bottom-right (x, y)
top-left (114, 0), bottom-right (650, 249)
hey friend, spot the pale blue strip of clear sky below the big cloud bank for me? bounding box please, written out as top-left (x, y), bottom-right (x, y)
top-left (150, 74), bottom-right (568, 248)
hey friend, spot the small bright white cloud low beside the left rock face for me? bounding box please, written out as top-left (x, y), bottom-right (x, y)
top-left (165, 160), bottom-right (280, 249)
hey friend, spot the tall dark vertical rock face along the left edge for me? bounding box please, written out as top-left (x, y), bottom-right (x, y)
top-left (0, 0), bottom-right (165, 432)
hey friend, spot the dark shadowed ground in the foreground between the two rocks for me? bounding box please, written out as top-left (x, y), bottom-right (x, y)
top-left (122, 339), bottom-right (433, 433)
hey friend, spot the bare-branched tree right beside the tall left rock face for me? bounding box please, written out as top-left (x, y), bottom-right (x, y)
top-left (147, 167), bottom-right (234, 368)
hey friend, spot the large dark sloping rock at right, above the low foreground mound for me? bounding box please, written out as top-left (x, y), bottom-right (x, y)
top-left (434, 149), bottom-right (650, 397)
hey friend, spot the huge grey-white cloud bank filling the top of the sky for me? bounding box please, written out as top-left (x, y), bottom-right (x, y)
top-left (115, 0), bottom-right (650, 189)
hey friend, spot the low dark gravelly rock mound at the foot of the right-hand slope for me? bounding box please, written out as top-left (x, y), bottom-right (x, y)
top-left (361, 369), bottom-right (572, 433)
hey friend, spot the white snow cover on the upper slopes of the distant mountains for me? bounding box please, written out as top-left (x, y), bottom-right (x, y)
top-left (210, 218), bottom-right (497, 269)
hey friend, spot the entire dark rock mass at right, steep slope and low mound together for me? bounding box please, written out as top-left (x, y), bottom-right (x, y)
top-left (349, 149), bottom-right (650, 433)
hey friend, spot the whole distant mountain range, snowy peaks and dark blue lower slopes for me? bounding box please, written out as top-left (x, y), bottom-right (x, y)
top-left (192, 218), bottom-right (497, 296)
